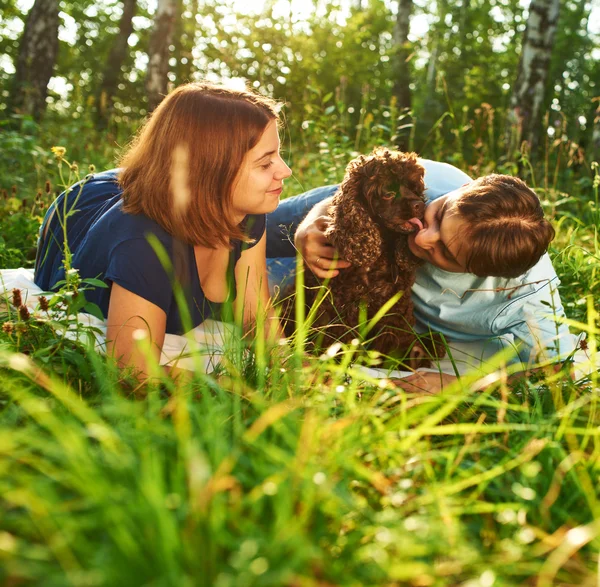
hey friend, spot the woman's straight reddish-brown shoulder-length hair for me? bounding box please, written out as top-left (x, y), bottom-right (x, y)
top-left (119, 82), bottom-right (278, 248)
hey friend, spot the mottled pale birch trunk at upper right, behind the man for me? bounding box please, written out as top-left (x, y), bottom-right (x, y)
top-left (508, 0), bottom-right (560, 151)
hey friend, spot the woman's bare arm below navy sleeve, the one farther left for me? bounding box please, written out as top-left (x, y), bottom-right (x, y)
top-left (106, 283), bottom-right (167, 380)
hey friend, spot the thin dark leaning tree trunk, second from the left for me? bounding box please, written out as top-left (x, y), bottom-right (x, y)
top-left (96, 0), bottom-right (137, 127)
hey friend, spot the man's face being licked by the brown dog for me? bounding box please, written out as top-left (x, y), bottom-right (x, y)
top-left (408, 186), bottom-right (474, 273)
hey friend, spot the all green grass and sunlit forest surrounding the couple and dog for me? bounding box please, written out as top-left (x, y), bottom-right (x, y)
top-left (0, 0), bottom-right (600, 587)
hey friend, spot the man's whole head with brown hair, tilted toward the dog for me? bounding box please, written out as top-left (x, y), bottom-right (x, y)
top-left (409, 174), bottom-right (554, 277)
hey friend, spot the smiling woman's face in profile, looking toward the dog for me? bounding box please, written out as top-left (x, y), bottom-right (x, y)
top-left (232, 120), bottom-right (292, 222)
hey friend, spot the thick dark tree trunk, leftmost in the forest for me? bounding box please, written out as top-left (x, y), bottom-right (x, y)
top-left (9, 0), bottom-right (59, 121)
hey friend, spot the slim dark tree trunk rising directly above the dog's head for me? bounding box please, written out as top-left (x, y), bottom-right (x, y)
top-left (394, 0), bottom-right (413, 150)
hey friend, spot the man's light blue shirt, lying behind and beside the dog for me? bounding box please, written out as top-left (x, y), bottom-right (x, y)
top-left (412, 159), bottom-right (576, 362)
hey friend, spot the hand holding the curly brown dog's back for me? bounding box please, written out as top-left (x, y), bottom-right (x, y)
top-left (294, 198), bottom-right (351, 279)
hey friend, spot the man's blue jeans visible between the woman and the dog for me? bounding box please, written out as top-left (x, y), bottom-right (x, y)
top-left (267, 185), bottom-right (338, 294)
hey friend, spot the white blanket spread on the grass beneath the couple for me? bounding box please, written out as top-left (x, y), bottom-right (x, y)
top-left (0, 268), bottom-right (600, 379)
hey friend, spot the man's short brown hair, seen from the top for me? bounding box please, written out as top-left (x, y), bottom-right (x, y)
top-left (452, 174), bottom-right (554, 277)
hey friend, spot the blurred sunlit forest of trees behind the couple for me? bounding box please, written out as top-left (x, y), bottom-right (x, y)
top-left (0, 0), bottom-right (600, 195)
